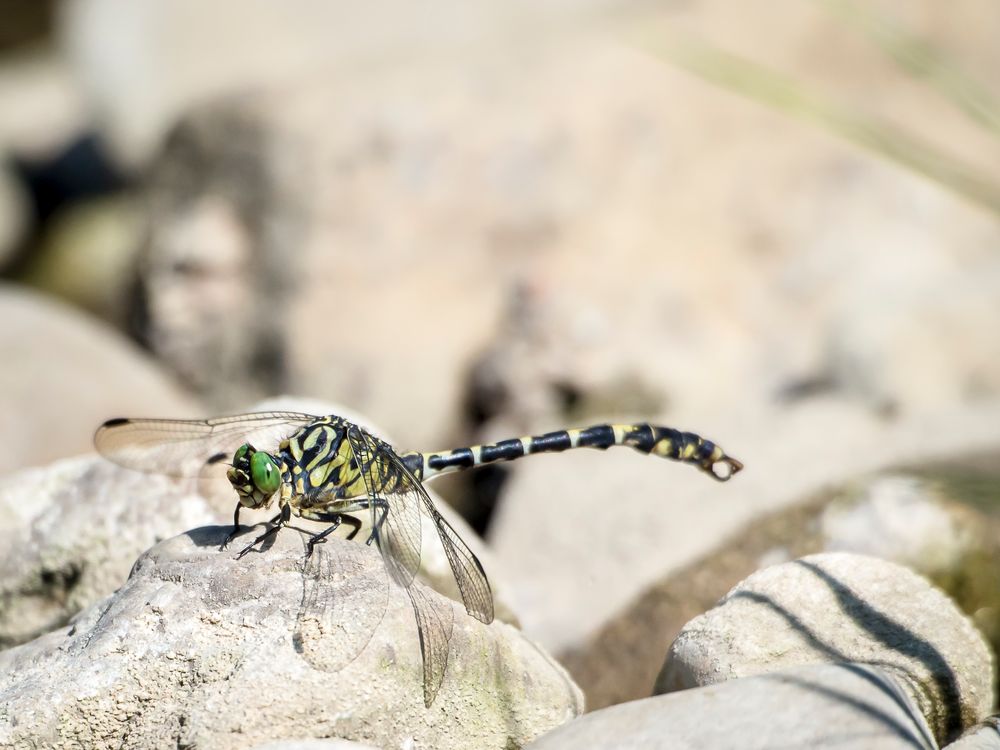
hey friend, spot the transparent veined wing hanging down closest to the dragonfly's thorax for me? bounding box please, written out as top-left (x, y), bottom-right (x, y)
top-left (347, 425), bottom-right (423, 588)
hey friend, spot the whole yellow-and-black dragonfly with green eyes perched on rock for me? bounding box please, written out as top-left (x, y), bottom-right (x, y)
top-left (94, 411), bottom-right (743, 708)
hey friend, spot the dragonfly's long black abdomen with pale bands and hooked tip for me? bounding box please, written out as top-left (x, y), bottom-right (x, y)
top-left (401, 422), bottom-right (743, 480)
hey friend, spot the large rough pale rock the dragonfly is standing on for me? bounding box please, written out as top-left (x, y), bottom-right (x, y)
top-left (0, 527), bottom-right (582, 748)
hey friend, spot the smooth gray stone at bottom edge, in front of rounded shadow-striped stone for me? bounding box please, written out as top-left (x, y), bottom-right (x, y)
top-left (528, 664), bottom-right (937, 750)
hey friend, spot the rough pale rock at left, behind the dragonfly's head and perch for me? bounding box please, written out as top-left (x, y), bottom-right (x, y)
top-left (0, 456), bottom-right (217, 646)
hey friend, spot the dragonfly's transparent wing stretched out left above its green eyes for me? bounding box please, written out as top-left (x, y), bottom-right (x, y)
top-left (94, 411), bottom-right (317, 477)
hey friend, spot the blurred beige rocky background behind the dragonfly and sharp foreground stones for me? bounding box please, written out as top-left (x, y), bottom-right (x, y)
top-left (0, 0), bottom-right (1000, 707)
